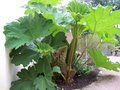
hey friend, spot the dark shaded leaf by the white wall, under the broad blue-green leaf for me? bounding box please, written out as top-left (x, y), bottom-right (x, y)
top-left (10, 47), bottom-right (39, 66)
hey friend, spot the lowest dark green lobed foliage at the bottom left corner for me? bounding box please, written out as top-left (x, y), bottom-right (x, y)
top-left (10, 57), bottom-right (56, 90)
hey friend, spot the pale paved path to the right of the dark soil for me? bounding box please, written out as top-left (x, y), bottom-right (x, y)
top-left (76, 56), bottom-right (120, 90)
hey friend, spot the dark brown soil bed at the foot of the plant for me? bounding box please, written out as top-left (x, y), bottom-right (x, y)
top-left (58, 69), bottom-right (99, 90)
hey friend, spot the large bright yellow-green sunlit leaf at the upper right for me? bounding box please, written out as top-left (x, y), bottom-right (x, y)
top-left (81, 6), bottom-right (120, 42)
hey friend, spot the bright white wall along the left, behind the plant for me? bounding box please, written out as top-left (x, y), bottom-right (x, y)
top-left (0, 0), bottom-right (27, 90)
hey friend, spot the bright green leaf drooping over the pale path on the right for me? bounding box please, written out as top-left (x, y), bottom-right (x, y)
top-left (88, 48), bottom-right (120, 71)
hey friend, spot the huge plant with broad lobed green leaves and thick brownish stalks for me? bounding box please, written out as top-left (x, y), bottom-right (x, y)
top-left (4, 0), bottom-right (120, 90)
